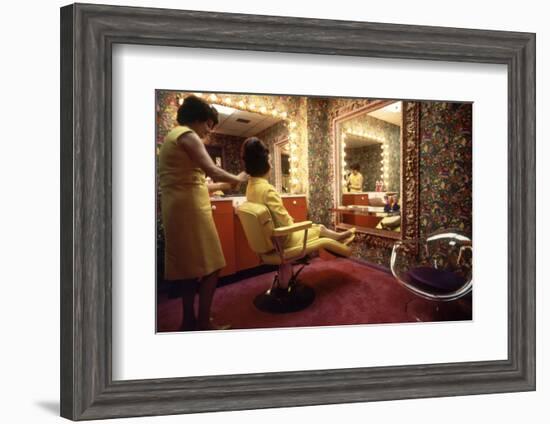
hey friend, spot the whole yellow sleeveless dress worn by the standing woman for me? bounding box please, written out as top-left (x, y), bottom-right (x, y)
top-left (159, 126), bottom-right (225, 280)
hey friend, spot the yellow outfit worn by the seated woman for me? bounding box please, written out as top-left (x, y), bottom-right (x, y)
top-left (246, 177), bottom-right (321, 248)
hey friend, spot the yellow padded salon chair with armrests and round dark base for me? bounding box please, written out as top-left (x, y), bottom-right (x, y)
top-left (237, 202), bottom-right (351, 313)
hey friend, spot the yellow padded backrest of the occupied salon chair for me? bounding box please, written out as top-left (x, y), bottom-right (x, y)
top-left (237, 202), bottom-right (275, 255)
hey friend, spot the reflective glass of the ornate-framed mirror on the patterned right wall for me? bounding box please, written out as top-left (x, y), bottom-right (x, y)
top-left (337, 102), bottom-right (403, 233)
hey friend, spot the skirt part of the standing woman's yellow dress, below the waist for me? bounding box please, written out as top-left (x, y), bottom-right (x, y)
top-left (161, 184), bottom-right (225, 280)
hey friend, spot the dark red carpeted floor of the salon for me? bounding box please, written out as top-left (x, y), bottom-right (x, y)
top-left (157, 258), bottom-right (472, 332)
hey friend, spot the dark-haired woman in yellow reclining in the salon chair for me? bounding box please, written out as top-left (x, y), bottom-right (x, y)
top-left (241, 137), bottom-right (355, 247)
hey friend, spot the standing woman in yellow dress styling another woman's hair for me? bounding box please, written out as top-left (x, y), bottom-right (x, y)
top-left (159, 96), bottom-right (248, 330)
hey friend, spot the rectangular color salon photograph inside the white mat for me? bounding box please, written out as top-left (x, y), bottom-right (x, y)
top-left (151, 89), bottom-right (475, 333)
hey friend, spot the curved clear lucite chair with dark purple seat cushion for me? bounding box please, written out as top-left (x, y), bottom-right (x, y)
top-left (390, 230), bottom-right (472, 321)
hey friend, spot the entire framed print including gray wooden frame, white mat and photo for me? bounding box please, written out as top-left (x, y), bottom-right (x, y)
top-left (61, 4), bottom-right (535, 420)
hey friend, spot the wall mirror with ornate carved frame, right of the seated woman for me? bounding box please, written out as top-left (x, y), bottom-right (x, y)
top-left (333, 100), bottom-right (418, 244)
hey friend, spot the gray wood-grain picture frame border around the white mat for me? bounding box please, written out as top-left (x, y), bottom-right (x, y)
top-left (60, 4), bottom-right (536, 420)
